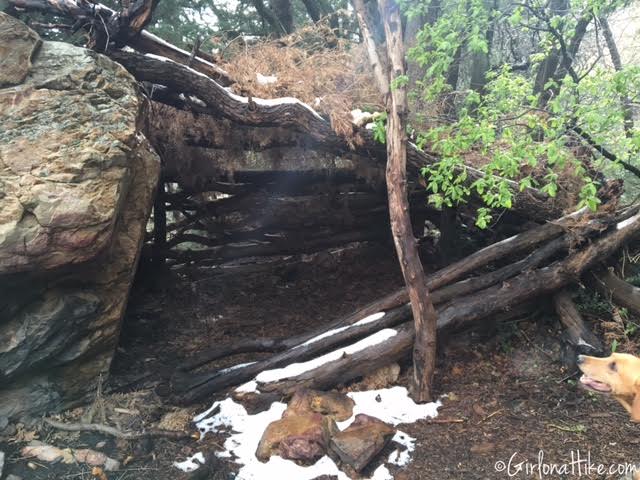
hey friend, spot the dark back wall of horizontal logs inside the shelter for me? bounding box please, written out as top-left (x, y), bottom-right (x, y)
top-left (150, 185), bottom-right (436, 265)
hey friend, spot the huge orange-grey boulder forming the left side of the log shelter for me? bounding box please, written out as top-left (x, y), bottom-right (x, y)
top-left (0, 12), bottom-right (160, 426)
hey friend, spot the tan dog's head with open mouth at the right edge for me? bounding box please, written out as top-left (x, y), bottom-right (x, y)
top-left (577, 353), bottom-right (640, 422)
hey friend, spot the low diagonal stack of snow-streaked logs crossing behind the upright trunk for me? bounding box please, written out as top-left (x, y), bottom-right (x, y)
top-left (171, 209), bottom-right (640, 403)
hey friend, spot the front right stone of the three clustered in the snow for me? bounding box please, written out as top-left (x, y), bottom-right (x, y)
top-left (329, 414), bottom-right (396, 472)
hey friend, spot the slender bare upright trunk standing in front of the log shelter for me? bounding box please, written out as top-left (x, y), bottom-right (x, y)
top-left (379, 0), bottom-right (437, 402)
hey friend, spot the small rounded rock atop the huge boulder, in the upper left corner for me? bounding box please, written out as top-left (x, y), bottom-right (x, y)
top-left (0, 12), bottom-right (42, 87)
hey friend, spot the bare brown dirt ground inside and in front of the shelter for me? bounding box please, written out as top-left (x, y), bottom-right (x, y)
top-left (0, 247), bottom-right (640, 480)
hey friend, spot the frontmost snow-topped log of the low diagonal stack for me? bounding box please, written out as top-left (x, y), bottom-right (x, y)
top-left (219, 214), bottom-right (640, 402)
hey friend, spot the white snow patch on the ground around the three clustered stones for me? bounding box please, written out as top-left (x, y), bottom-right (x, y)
top-left (190, 387), bottom-right (441, 480)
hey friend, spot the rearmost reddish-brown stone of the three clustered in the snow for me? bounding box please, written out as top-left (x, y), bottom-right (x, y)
top-left (283, 389), bottom-right (355, 422)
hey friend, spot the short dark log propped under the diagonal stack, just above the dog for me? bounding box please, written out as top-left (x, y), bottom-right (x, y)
top-left (553, 289), bottom-right (604, 355)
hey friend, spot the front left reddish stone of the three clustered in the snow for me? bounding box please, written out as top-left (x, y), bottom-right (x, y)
top-left (256, 413), bottom-right (338, 464)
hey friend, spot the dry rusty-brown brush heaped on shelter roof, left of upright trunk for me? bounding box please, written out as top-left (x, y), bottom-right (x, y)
top-left (222, 25), bottom-right (383, 138)
